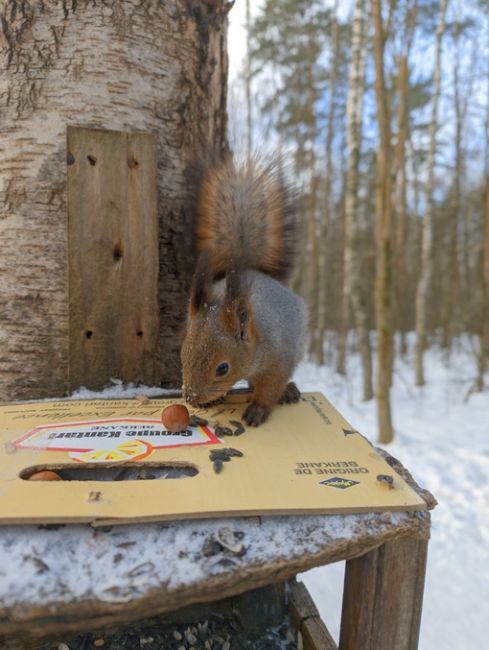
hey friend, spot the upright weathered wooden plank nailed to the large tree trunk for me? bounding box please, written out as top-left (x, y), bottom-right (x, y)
top-left (67, 127), bottom-right (159, 390)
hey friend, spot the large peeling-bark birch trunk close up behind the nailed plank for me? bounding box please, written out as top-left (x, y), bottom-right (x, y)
top-left (0, 0), bottom-right (228, 400)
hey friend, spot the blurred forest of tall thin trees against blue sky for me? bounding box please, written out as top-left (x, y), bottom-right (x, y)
top-left (230, 0), bottom-right (489, 442)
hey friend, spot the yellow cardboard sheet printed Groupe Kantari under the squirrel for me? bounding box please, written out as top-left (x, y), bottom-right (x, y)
top-left (0, 393), bottom-right (426, 525)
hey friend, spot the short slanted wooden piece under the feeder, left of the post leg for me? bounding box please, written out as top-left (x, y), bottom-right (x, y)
top-left (289, 582), bottom-right (338, 650)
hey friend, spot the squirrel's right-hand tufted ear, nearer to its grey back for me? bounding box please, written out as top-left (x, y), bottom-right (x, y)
top-left (221, 269), bottom-right (255, 341)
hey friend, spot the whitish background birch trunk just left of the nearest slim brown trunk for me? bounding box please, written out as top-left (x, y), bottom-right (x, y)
top-left (339, 0), bottom-right (373, 400)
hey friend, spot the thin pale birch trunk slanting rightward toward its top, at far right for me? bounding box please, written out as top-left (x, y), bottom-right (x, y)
top-left (414, 0), bottom-right (448, 386)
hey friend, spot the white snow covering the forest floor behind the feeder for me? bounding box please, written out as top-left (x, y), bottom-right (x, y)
top-left (295, 336), bottom-right (489, 650)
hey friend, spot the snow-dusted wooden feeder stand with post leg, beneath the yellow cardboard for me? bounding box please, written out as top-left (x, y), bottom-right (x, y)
top-left (0, 452), bottom-right (436, 650)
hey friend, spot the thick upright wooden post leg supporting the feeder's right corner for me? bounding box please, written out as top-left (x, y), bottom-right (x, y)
top-left (339, 537), bottom-right (428, 650)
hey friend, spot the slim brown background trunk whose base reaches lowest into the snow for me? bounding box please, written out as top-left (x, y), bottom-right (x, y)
top-left (372, 0), bottom-right (394, 443)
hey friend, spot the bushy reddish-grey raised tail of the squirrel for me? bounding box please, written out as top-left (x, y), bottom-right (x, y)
top-left (197, 155), bottom-right (297, 282)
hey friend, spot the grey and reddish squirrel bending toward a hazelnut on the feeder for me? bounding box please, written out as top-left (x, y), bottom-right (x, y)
top-left (181, 155), bottom-right (307, 426)
